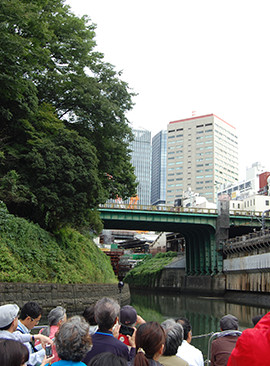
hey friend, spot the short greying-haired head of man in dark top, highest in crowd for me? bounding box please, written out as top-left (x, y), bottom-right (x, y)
top-left (95, 297), bottom-right (120, 330)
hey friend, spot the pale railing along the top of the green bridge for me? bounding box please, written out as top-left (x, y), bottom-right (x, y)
top-left (99, 202), bottom-right (263, 217)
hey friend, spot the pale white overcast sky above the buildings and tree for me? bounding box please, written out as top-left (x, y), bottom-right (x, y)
top-left (66, 0), bottom-right (270, 179)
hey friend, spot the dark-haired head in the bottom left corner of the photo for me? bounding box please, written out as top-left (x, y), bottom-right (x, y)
top-left (0, 339), bottom-right (29, 366)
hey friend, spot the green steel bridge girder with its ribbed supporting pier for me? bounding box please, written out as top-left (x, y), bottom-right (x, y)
top-left (99, 208), bottom-right (269, 275)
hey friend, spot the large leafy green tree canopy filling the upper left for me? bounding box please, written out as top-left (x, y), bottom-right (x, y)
top-left (0, 0), bottom-right (136, 229)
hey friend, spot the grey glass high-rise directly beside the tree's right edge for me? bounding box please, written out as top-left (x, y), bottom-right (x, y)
top-left (130, 129), bottom-right (152, 205)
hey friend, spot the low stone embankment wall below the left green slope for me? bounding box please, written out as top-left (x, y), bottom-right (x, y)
top-left (0, 282), bottom-right (130, 314)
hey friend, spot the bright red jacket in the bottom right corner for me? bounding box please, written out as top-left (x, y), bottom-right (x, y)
top-left (227, 312), bottom-right (270, 366)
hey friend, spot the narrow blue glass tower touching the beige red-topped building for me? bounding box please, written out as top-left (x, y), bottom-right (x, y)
top-left (151, 130), bottom-right (167, 205)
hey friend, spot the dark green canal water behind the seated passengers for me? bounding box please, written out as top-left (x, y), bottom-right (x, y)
top-left (130, 291), bottom-right (270, 359)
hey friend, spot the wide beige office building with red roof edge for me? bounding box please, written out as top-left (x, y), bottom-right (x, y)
top-left (166, 114), bottom-right (238, 205)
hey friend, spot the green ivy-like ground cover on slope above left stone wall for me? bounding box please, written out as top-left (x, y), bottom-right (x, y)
top-left (0, 203), bottom-right (117, 283)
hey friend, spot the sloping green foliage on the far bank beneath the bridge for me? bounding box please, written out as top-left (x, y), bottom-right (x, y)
top-left (124, 252), bottom-right (177, 287)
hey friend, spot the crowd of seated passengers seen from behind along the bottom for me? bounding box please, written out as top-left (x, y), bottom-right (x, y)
top-left (0, 297), bottom-right (270, 366)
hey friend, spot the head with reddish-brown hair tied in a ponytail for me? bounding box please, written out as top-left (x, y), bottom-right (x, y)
top-left (134, 322), bottom-right (165, 366)
